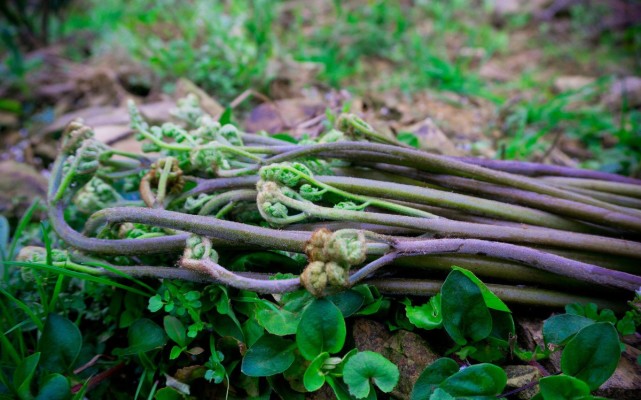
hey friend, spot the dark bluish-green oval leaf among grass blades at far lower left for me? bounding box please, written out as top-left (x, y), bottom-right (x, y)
top-left (38, 314), bottom-right (82, 372)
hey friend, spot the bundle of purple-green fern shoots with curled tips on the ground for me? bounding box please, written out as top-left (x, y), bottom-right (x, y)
top-left (43, 97), bottom-right (641, 307)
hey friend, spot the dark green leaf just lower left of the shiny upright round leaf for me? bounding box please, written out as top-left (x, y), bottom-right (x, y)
top-left (240, 333), bottom-right (296, 377)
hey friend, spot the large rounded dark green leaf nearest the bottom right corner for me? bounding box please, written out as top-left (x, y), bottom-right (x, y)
top-left (561, 322), bottom-right (621, 390)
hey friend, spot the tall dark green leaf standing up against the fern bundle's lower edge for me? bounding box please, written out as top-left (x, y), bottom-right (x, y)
top-left (441, 269), bottom-right (492, 346)
